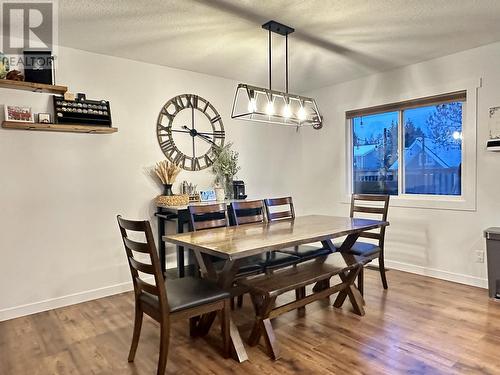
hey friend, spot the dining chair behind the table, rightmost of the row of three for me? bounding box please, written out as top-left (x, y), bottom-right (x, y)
top-left (264, 197), bottom-right (331, 262)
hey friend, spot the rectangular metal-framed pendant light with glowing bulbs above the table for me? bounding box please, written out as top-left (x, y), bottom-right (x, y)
top-left (231, 21), bottom-right (323, 129)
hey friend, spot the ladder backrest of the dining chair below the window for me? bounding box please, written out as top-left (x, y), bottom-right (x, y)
top-left (351, 194), bottom-right (390, 248)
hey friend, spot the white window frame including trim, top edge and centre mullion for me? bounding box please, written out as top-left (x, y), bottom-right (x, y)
top-left (345, 79), bottom-right (481, 211)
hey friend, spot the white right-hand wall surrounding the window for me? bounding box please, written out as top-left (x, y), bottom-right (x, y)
top-left (296, 43), bottom-right (500, 287)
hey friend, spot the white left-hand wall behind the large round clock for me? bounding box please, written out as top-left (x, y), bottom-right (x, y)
top-left (0, 48), bottom-right (301, 320)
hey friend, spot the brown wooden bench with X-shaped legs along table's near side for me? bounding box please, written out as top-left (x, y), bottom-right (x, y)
top-left (239, 253), bottom-right (365, 360)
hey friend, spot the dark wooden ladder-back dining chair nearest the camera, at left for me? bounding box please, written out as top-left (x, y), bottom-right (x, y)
top-left (117, 215), bottom-right (231, 375)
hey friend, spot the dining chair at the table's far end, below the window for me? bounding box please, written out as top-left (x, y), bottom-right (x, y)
top-left (336, 194), bottom-right (390, 294)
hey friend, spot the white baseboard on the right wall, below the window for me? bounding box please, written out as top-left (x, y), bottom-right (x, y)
top-left (385, 259), bottom-right (488, 289)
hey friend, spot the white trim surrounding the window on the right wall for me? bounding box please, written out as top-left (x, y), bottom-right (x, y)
top-left (344, 78), bottom-right (482, 211)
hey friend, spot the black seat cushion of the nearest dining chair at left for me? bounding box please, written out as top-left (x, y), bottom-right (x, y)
top-left (139, 277), bottom-right (231, 313)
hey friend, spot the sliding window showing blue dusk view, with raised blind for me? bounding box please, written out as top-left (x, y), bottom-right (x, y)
top-left (346, 91), bottom-right (465, 196)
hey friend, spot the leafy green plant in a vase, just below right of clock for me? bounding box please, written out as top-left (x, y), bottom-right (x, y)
top-left (212, 142), bottom-right (240, 199)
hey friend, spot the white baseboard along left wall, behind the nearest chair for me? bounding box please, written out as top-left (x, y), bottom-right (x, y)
top-left (0, 281), bottom-right (139, 322)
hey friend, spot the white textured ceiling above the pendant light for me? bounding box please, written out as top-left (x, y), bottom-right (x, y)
top-left (59, 0), bottom-right (500, 92)
